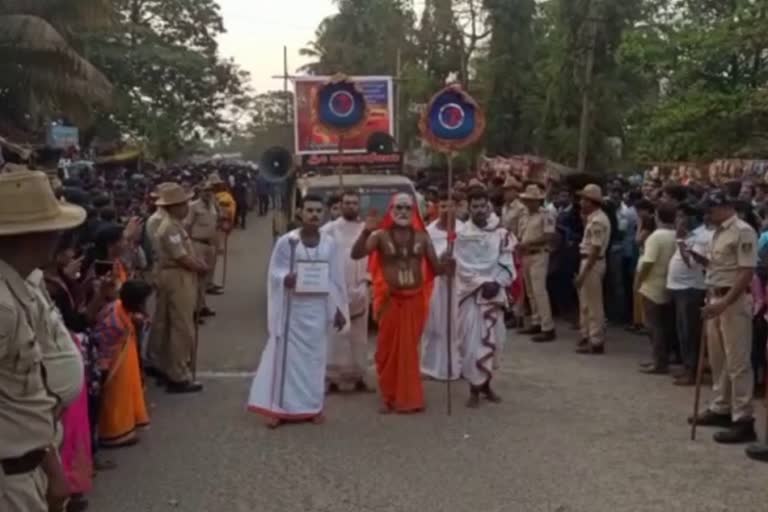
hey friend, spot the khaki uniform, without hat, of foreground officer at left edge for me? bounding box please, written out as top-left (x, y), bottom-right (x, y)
top-left (0, 261), bottom-right (58, 512)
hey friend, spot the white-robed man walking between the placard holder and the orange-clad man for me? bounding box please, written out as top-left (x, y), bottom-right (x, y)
top-left (321, 191), bottom-right (371, 393)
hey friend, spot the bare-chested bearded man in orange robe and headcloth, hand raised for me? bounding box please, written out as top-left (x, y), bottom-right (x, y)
top-left (352, 194), bottom-right (453, 413)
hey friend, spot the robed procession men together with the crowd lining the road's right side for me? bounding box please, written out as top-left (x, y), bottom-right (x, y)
top-left (249, 168), bottom-right (768, 460)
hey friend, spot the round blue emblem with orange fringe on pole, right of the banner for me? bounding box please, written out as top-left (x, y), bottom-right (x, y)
top-left (419, 85), bottom-right (485, 152)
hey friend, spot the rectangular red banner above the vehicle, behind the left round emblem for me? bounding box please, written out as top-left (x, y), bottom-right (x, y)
top-left (294, 76), bottom-right (395, 155)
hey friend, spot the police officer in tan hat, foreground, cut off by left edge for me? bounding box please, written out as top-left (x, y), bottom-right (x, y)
top-left (0, 171), bottom-right (86, 512)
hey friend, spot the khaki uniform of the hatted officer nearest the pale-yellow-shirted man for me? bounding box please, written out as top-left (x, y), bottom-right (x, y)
top-left (578, 209), bottom-right (611, 347)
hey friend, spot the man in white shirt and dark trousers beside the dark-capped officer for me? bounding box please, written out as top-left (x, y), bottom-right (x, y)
top-left (667, 204), bottom-right (713, 386)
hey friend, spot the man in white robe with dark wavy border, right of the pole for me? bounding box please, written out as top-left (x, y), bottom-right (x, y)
top-left (455, 190), bottom-right (516, 408)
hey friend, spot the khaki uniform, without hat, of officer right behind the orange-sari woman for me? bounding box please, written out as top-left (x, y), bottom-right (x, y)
top-left (150, 215), bottom-right (198, 383)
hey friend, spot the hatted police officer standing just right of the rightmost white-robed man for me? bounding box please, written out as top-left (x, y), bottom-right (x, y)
top-left (518, 184), bottom-right (557, 343)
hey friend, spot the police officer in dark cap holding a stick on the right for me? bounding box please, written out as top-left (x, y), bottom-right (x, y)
top-left (681, 191), bottom-right (757, 444)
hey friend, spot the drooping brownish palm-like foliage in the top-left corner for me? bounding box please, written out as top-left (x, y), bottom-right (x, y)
top-left (0, 0), bottom-right (112, 129)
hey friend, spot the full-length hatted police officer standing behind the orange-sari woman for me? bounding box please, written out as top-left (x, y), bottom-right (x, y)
top-left (150, 184), bottom-right (208, 393)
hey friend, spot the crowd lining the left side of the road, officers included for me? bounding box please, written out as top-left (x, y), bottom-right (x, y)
top-left (0, 164), bottom-right (260, 512)
